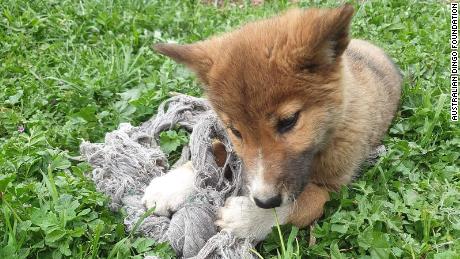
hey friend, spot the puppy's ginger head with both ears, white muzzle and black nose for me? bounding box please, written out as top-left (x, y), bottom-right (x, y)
top-left (155, 5), bottom-right (353, 208)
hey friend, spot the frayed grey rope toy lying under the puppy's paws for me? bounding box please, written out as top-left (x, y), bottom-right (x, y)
top-left (80, 95), bottom-right (380, 259)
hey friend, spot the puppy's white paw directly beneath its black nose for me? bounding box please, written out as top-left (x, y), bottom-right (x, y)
top-left (216, 196), bottom-right (290, 244)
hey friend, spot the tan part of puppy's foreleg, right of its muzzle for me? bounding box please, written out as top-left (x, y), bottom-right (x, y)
top-left (288, 183), bottom-right (329, 227)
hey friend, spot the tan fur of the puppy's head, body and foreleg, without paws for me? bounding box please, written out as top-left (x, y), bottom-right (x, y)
top-left (156, 5), bottom-right (401, 230)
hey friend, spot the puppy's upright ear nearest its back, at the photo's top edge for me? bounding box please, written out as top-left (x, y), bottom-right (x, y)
top-left (292, 4), bottom-right (354, 70)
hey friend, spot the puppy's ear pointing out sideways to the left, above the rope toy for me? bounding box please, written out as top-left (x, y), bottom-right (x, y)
top-left (153, 42), bottom-right (213, 84)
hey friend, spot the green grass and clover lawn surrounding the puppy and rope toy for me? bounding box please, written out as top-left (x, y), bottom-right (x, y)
top-left (0, 0), bottom-right (460, 259)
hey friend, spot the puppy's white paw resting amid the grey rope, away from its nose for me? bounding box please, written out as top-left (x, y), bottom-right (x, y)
top-left (142, 162), bottom-right (196, 217)
